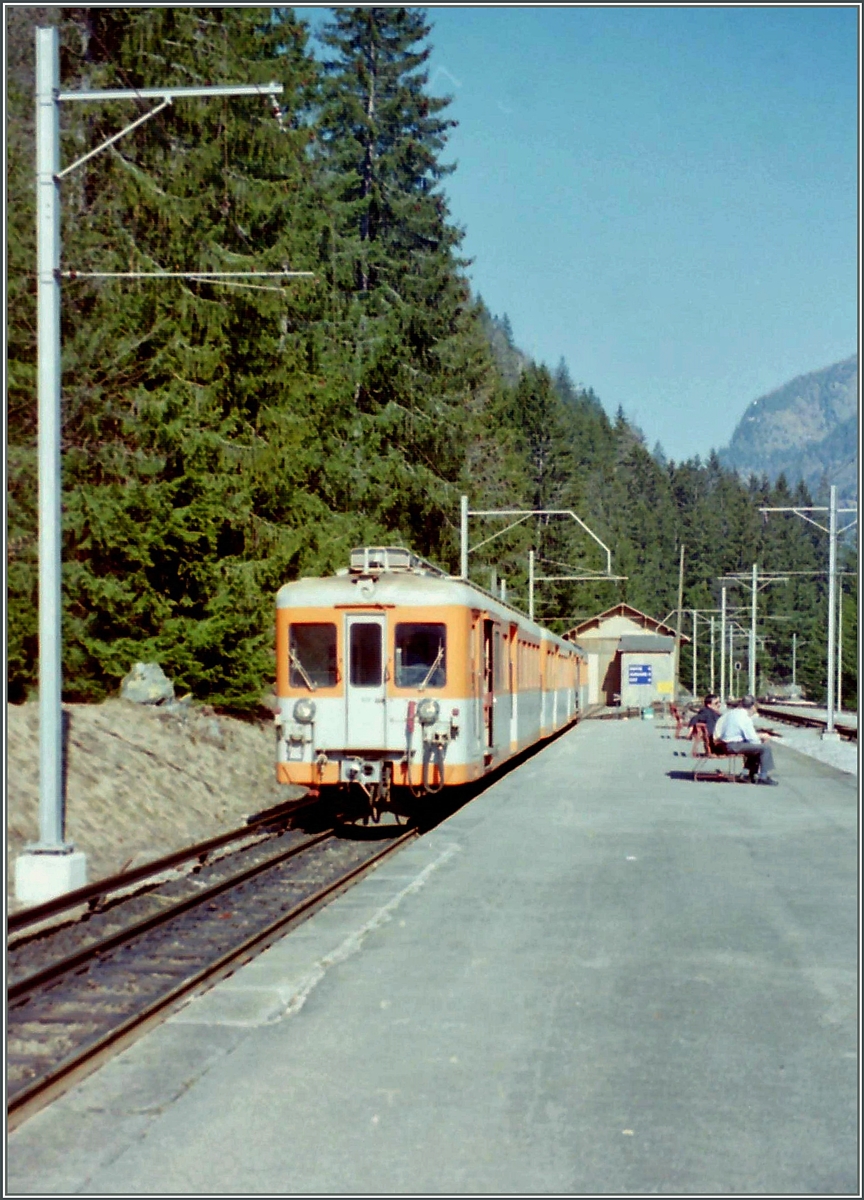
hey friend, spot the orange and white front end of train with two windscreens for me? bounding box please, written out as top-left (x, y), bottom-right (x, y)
top-left (276, 547), bottom-right (470, 815)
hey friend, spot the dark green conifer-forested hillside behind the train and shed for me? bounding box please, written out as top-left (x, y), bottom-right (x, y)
top-left (7, 7), bottom-right (857, 710)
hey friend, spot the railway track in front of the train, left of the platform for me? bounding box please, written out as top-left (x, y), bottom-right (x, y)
top-left (6, 811), bottom-right (418, 1129)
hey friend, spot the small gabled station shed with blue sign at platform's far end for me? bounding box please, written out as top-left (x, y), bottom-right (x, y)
top-left (564, 604), bottom-right (689, 708)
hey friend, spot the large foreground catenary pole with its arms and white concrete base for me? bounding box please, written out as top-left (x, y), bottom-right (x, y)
top-left (16, 26), bottom-right (288, 904)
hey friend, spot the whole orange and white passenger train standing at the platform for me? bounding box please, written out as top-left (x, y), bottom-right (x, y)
top-left (276, 547), bottom-right (587, 817)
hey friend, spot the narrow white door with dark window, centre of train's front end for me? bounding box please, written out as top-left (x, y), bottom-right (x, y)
top-left (346, 616), bottom-right (386, 750)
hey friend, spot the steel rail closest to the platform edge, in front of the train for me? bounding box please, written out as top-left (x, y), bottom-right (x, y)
top-left (7, 829), bottom-right (419, 1132)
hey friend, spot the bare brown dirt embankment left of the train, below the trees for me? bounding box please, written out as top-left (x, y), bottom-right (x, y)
top-left (6, 700), bottom-right (301, 910)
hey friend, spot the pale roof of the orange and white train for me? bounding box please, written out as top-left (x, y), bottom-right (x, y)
top-left (276, 547), bottom-right (584, 654)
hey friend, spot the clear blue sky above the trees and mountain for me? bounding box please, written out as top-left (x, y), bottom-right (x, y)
top-left (295, 5), bottom-right (859, 460)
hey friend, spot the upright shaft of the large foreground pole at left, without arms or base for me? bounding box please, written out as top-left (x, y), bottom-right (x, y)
top-left (36, 28), bottom-right (68, 851)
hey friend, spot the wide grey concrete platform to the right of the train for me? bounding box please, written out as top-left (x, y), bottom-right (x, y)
top-left (6, 721), bottom-right (859, 1195)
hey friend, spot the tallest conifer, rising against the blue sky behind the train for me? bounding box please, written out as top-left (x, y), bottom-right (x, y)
top-left (318, 7), bottom-right (491, 560)
